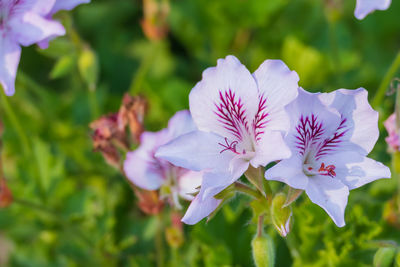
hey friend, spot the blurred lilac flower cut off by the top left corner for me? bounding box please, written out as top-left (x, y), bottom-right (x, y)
top-left (0, 0), bottom-right (89, 96)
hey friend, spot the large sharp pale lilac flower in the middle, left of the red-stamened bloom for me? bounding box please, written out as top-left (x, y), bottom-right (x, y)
top-left (156, 56), bottom-right (299, 224)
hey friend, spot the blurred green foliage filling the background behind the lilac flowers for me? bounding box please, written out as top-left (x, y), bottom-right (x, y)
top-left (0, 0), bottom-right (400, 267)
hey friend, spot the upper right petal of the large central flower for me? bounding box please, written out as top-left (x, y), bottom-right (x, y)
top-left (253, 60), bottom-right (299, 131)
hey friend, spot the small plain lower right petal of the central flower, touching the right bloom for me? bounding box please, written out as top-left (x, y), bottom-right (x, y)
top-left (250, 131), bottom-right (292, 168)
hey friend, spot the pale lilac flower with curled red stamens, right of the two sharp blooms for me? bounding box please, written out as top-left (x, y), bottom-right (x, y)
top-left (265, 88), bottom-right (390, 227)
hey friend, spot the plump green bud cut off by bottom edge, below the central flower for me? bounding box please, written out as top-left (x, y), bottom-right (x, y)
top-left (251, 234), bottom-right (275, 267)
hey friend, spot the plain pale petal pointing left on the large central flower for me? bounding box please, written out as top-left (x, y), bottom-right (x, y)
top-left (156, 131), bottom-right (235, 172)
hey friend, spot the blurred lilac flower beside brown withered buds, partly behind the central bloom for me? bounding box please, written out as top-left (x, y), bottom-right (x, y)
top-left (124, 110), bottom-right (202, 208)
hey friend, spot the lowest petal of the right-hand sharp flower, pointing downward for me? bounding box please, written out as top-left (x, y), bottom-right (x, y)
top-left (306, 175), bottom-right (349, 227)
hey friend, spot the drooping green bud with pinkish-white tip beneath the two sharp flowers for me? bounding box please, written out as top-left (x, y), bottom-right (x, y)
top-left (271, 193), bottom-right (292, 237)
